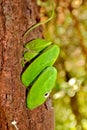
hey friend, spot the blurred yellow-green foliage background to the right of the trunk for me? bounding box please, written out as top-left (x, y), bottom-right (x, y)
top-left (37, 0), bottom-right (87, 130)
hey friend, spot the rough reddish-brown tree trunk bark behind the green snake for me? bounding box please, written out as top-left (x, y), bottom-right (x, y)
top-left (0, 0), bottom-right (54, 130)
